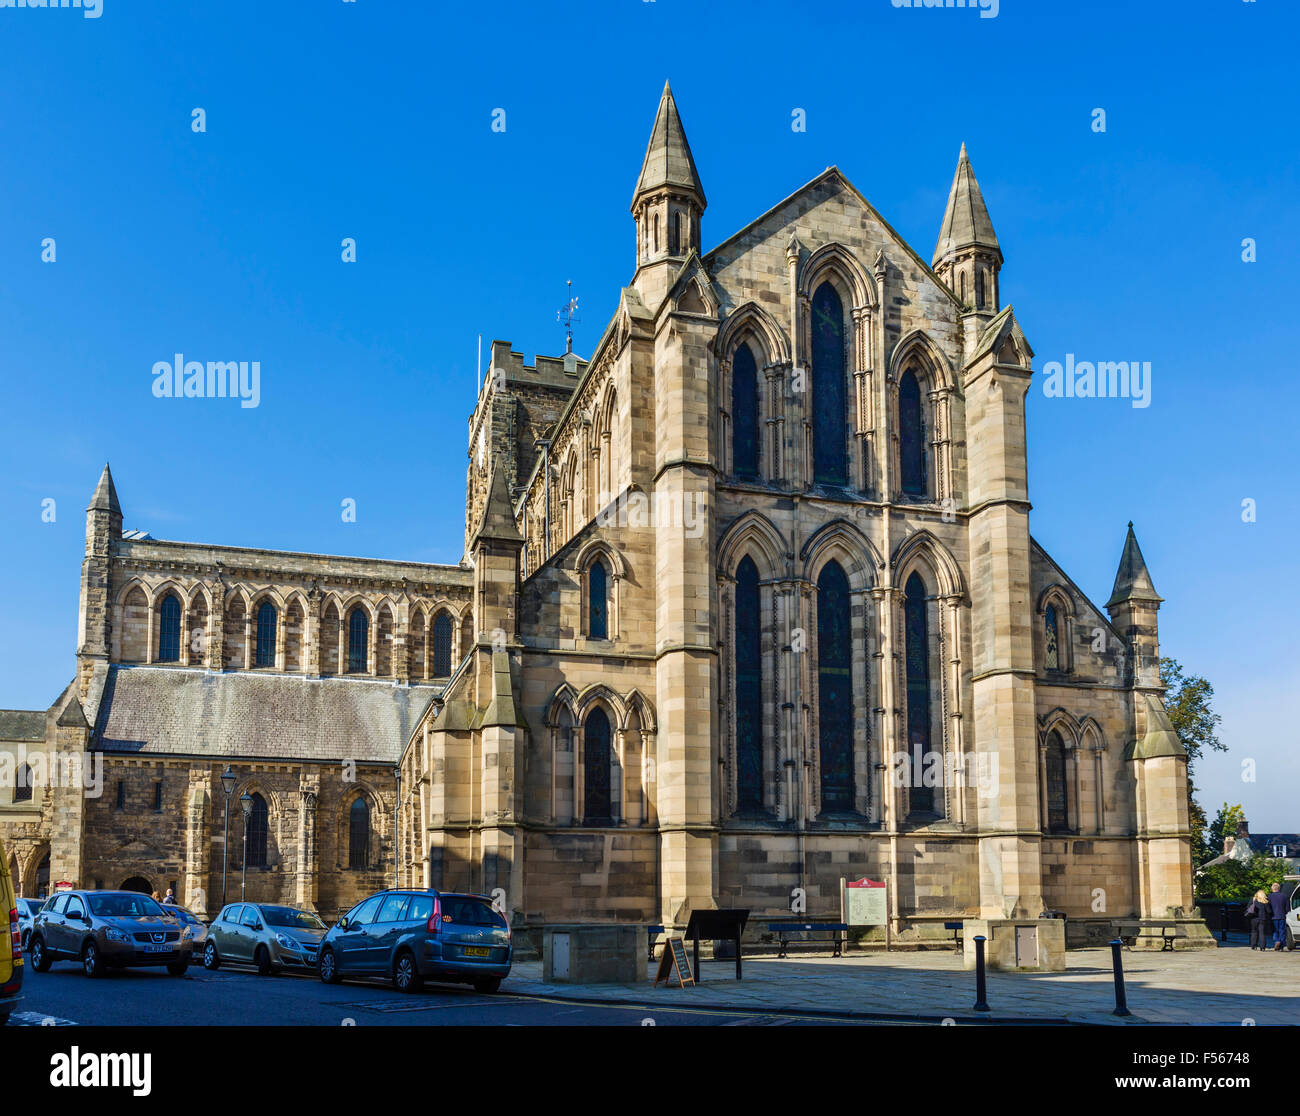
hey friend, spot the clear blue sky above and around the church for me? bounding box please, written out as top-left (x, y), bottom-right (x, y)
top-left (0, 0), bottom-right (1300, 831)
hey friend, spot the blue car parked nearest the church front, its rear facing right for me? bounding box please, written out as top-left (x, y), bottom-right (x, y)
top-left (317, 888), bottom-right (512, 992)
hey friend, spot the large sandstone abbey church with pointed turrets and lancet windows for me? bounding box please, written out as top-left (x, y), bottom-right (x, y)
top-left (0, 86), bottom-right (1192, 942)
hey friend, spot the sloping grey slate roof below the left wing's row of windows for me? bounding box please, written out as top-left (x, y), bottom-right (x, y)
top-left (95, 666), bottom-right (438, 764)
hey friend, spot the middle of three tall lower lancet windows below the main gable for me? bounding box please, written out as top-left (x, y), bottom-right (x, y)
top-left (816, 562), bottom-right (853, 814)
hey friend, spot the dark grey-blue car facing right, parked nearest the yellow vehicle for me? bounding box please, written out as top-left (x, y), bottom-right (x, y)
top-left (31, 891), bottom-right (194, 977)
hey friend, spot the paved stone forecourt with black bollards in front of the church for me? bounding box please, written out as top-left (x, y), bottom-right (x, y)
top-left (508, 943), bottom-right (1300, 1026)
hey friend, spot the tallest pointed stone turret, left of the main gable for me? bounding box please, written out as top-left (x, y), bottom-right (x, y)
top-left (632, 82), bottom-right (707, 310)
